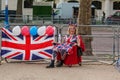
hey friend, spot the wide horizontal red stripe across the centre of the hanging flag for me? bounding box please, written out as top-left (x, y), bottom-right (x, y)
top-left (2, 40), bottom-right (53, 50)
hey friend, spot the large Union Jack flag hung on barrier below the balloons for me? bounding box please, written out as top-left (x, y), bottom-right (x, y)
top-left (1, 28), bottom-right (54, 61)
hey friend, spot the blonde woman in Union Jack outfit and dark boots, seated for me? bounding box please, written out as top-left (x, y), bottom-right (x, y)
top-left (46, 24), bottom-right (84, 68)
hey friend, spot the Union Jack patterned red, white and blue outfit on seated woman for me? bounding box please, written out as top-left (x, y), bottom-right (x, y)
top-left (53, 35), bottom-right (78, 59)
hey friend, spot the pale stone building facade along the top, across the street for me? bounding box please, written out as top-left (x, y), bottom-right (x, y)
top-left (0, 0), bottom-right (120, 17)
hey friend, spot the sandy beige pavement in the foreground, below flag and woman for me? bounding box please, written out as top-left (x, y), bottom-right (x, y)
top-left (0, 62), bottom-right (120, 80)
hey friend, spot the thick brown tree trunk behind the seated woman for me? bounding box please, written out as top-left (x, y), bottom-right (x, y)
top-left (78, 0), bottom-right (92, 55)
